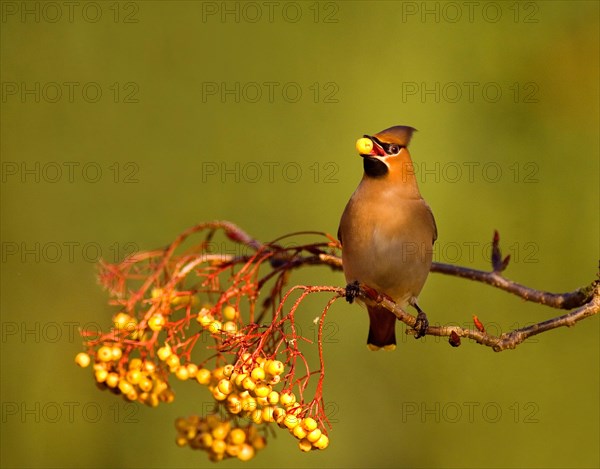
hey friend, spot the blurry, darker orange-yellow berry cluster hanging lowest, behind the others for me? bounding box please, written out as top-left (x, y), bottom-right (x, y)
top-left (175, 414), bottom-right (267, 462)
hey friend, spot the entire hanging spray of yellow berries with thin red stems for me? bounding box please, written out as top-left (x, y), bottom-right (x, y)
top-left (75, 222), bottom-right (335, 461)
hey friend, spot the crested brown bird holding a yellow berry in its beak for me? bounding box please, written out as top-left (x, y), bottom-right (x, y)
top-left (338, 125), bottom-right (437, 350)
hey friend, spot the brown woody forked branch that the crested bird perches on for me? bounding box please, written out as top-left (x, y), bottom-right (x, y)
top-left (105, 221), bottom-right (600, 351)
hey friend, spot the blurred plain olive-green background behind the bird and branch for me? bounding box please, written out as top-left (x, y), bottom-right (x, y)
top-left (1, 1), bottom-right (600, 468)
